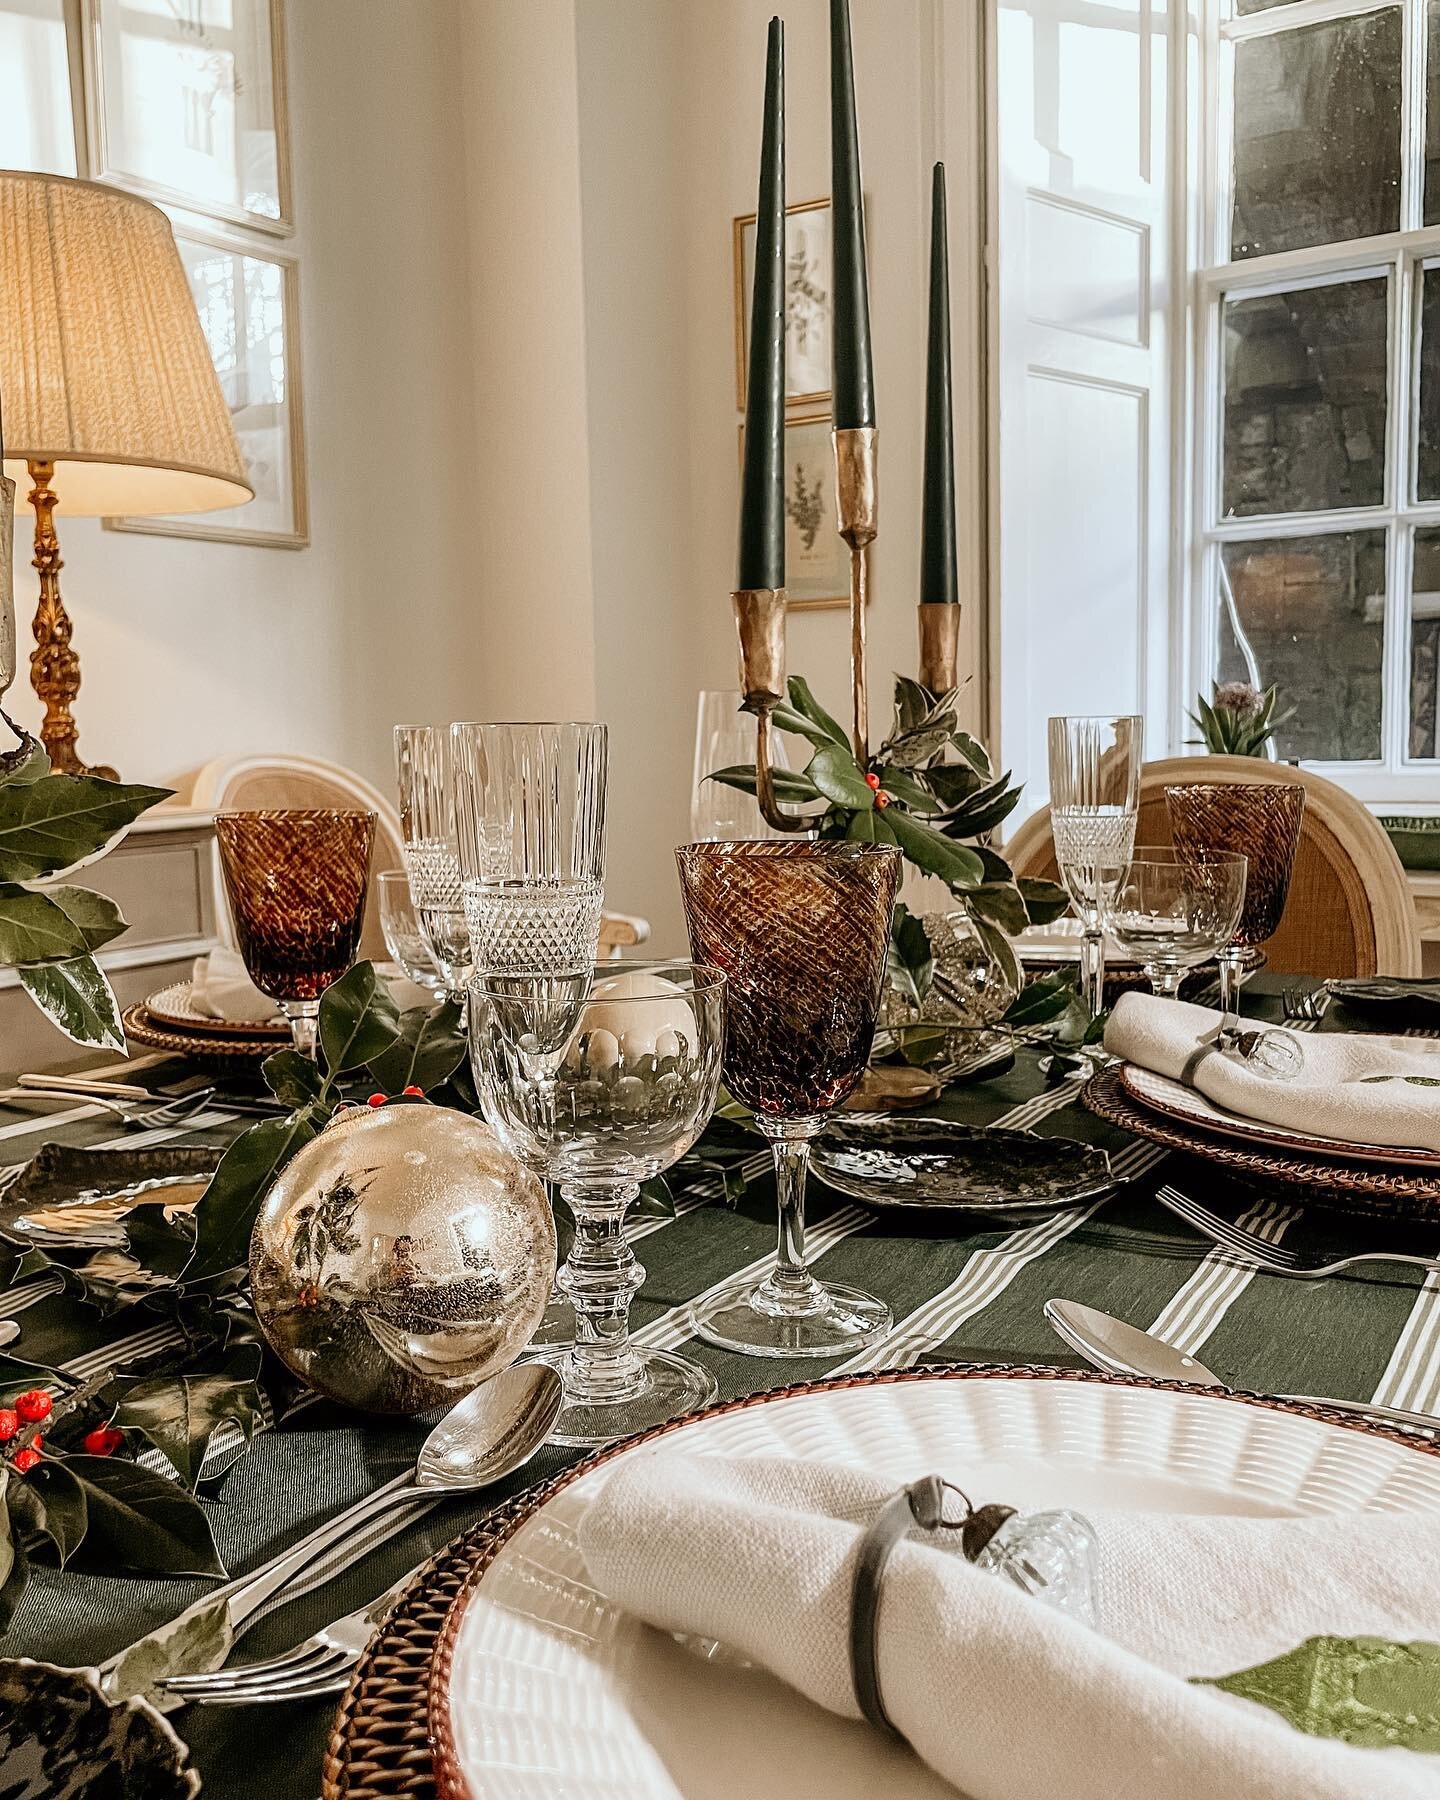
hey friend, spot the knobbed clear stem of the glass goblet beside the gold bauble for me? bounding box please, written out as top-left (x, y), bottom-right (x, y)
top-left (556, 1183), bottom-right (646, 1406)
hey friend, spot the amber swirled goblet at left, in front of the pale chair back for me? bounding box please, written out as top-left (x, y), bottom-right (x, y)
top-left (214, 810), bottom-right (374, 1058)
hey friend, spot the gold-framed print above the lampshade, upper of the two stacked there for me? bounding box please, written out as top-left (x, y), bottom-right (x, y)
top-left (83, 0), bottom-right (292, 232)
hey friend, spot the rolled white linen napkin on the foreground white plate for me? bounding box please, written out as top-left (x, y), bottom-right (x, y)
top-left (580, 1449), bottom-right (1440, 1800)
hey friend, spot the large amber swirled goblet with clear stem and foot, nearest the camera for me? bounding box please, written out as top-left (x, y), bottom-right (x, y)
top-left (675, 839), bottom-right (900, 1357)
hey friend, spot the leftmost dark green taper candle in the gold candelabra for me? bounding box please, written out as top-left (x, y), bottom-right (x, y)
top-left (734, 18), bottom-right (785, 592)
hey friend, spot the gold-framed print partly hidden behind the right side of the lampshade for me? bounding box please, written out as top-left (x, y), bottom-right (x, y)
top-left (106, 230), bottom-right (310, 549)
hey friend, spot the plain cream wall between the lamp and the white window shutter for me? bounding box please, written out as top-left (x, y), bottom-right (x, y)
top-left (2, 0), bottom-right (985, 952)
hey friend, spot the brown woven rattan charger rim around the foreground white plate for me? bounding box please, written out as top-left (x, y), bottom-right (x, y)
top-left (320, 1363), bottom-right (1440, 1800)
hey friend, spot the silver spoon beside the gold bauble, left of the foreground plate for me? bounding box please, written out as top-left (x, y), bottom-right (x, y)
top-left (101, 1363), bottom-right (563, 1697)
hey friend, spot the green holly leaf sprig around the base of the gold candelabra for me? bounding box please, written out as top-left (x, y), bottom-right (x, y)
top-left (709, 675), bottom-right (1069, 986)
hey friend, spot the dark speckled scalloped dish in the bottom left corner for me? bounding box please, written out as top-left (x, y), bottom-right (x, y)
top-left (0, 1656), bottom-right (200, 1800)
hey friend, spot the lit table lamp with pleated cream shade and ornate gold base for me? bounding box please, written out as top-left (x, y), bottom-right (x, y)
top-left (0, 169), bottom-right (254, 779)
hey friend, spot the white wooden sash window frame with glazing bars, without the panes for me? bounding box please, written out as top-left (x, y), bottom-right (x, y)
top-left (1188, 0), bottom-right (1440, 803)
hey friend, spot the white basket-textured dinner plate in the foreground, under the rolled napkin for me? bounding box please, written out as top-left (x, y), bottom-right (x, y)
top-left (430, 1375), bottom-right (1440, 1800)
